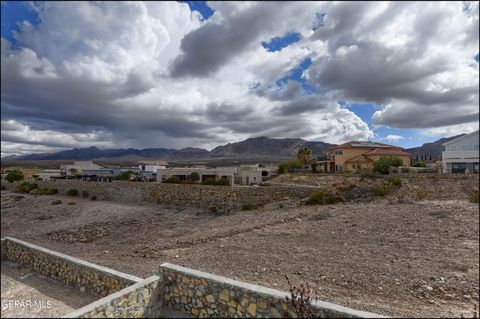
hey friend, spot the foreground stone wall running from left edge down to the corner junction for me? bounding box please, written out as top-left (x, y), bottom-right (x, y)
top-left (2, 237), bottom-right (143, 297)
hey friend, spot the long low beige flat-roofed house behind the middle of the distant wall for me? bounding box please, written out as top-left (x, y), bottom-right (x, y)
top-left (157, 167), bottom-right (235, 186)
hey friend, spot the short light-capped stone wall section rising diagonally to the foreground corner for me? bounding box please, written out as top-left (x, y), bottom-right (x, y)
top-left (63, 276), bottom-right (162, 318)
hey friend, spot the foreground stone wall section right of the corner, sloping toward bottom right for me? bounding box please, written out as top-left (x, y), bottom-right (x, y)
top-left (159, 263), bottom-right (382, 318)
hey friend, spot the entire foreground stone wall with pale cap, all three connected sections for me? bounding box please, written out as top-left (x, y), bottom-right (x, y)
top-left (1, 237), bottom-right (385, 318)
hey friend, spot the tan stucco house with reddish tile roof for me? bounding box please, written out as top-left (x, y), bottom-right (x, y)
top-left (317, 141), bottom-right (410, 173)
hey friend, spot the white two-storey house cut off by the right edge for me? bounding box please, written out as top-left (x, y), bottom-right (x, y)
top-left (442, 131), bottom-right (479, 173)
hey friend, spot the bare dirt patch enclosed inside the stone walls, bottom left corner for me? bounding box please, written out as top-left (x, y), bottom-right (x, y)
top-left (2, 261), bottom-right (97, 318)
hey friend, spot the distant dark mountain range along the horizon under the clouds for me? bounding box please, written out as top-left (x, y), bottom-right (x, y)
top-left (2, 134), bottom-right (464, 162)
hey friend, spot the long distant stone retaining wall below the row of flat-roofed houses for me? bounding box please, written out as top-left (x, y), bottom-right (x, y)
top-left (2, 180), bottom-right (313, 208)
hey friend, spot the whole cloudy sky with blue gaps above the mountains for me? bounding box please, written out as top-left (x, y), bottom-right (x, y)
top-left (1, 1), bottom-right (479, 157)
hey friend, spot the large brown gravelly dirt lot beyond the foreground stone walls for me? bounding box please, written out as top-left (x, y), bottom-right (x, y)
top-left (1, 176), bottom-right (479, 317)
